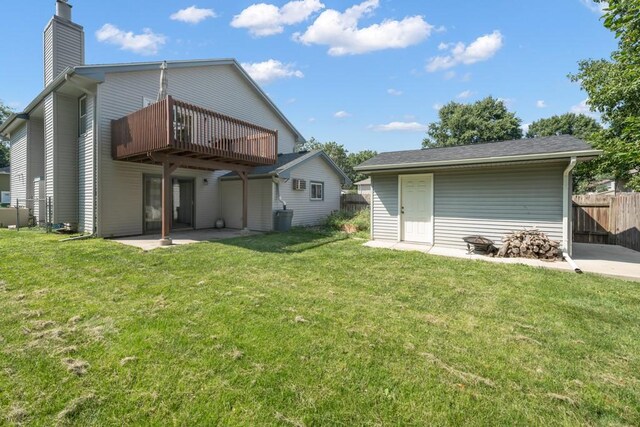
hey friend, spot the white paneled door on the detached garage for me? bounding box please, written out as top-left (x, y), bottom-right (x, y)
top-left (399, 174), bottom-right (433, 243)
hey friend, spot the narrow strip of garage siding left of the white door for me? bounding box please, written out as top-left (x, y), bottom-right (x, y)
top-left (371, 175), bottom-right (398, 240)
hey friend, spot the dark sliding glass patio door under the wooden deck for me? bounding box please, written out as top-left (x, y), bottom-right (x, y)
top-left (143, 175), bottom-right (194, 234)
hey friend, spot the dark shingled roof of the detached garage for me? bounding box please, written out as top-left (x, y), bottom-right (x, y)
top-left (355, 135), bottom-right (601, 171)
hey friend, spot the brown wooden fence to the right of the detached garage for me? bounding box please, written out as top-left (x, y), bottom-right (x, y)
top-left (573, 193), bottom-right (640, 251)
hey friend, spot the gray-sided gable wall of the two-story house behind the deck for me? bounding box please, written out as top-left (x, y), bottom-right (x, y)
top-left (98, 66), bottom-right (295, 236)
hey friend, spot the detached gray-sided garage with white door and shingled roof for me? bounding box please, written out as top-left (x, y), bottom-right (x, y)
top-left (355, 136), bottom-right (601, 254)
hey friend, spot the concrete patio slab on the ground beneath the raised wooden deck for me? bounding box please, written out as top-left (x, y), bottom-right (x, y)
top-left (111, 228), bottom-right (260, 251)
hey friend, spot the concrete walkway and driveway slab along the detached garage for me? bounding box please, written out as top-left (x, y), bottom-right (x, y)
top-left (364, 240), bottom-right (640, 281)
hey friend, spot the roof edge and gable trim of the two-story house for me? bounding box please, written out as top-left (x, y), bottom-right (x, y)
top-left (0, 58), bottom-right (305, 143)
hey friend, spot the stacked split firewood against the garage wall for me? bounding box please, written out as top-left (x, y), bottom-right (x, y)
top-left (496, 229), bottom-right (560, 260)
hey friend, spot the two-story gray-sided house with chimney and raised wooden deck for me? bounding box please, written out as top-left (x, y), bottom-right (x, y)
top-left (0, 0), bottom-right (345, 238)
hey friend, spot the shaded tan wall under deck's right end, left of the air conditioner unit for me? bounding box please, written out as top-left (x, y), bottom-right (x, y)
top-left (220, 179), bottom-right (273, 231)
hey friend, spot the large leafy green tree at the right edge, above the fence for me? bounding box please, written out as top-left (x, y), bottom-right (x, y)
top-left (570, 0), bottom-right (640, 191)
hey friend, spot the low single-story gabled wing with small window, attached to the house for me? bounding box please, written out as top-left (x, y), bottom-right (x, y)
top-left (220, 150), bottom-right (351, 231)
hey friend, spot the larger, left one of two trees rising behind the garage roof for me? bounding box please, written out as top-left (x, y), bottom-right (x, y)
top-left (422, 96), bottom-right (522, 148)
